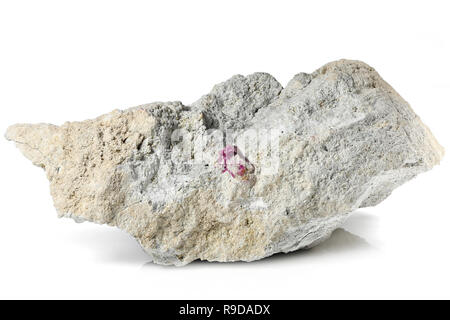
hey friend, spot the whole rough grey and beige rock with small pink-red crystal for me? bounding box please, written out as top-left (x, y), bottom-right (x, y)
top-left (6, 60), bottom-right (443, 265)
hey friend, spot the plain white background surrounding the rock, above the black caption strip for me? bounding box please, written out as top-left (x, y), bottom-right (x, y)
top-left (0, 0), bottom-right (450, 299)
